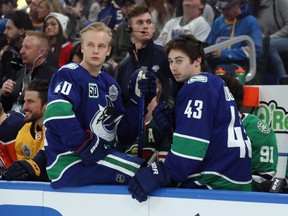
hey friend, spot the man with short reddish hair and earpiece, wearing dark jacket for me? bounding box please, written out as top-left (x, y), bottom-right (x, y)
top-left (1, 31), bottom-right (57, 111)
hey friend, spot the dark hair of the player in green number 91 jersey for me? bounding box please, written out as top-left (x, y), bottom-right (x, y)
top-left (220, 76), bottom-right (244, 110)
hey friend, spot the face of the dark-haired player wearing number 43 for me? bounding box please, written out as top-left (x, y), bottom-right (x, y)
top-left (168, 49), bottom-right (201, 82)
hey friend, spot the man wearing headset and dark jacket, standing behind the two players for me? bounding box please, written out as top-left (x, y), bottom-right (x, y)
top-left (117, 4), bottom-right (179, 103)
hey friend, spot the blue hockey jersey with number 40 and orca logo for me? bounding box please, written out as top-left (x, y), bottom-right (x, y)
top-left (44, 63), bottom-right (140, 187)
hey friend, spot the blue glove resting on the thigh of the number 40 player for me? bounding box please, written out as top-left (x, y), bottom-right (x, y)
top-left (74, 130), bottom-right (109, 166)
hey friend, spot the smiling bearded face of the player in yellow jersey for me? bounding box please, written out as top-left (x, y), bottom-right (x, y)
top-left (23, 91), bottom-right (45, 122)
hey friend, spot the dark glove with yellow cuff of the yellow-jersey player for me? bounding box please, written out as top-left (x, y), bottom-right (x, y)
top-left (3, 159), bottom-right (40, 181)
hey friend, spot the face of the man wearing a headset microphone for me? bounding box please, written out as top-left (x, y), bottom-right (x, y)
top-left (131, 13), bottom-right (155, 42)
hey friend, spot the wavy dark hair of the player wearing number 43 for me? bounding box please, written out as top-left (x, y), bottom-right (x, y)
top-left (165, 34), bottom-right (206, 71)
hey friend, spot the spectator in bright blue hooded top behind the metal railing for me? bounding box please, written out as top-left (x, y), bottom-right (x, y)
top-left (207, 0), bottom-right (262, 75)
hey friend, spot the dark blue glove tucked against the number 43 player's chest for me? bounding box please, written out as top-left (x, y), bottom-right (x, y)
top-left (152, 98), bottom-right (175, 131)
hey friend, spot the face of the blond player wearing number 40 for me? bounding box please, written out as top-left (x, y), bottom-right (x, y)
top-left (81, 31), bottom-right (111, 69)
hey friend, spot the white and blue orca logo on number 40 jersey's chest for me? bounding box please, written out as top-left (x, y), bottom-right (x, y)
top-left (90, 95), bottom-right (122, 142)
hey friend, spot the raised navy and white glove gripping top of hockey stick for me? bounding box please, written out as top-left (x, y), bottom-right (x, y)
top-left (128, 69), bottom-right (156, 104)
